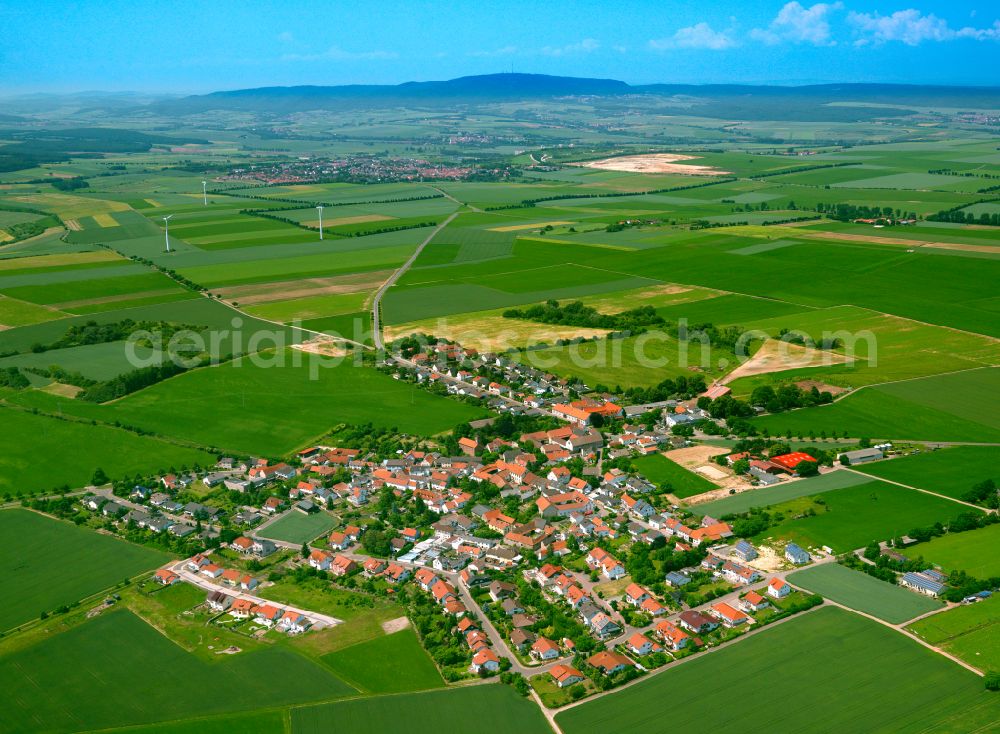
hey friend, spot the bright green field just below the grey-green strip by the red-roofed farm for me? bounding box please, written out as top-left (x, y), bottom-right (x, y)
top-left (762, 482), bottom-right (975, 553)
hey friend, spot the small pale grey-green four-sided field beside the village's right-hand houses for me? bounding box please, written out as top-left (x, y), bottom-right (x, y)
top-left (788, 563), bottom-right (943, 624)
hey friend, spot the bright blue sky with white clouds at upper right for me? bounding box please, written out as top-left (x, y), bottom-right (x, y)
top-left (0, 0), bottom-right (1000, 94)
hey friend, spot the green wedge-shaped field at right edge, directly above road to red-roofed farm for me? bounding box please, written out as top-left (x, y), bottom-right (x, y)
top-left (753, 369), bottom-right (1000, 442)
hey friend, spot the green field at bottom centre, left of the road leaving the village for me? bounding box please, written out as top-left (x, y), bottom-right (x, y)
top-left (292, 685), bottom-right (551, 734)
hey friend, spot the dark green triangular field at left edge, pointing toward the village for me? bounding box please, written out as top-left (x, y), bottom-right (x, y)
top-left (0, 509), bottom-right (170, 631)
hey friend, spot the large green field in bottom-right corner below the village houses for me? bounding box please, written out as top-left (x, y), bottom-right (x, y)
top-left (556, 608), bottom-right (1000, 734)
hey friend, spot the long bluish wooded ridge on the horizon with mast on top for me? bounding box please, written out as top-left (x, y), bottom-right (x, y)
top-left (152, 74), bottom-right (1000, 121)
